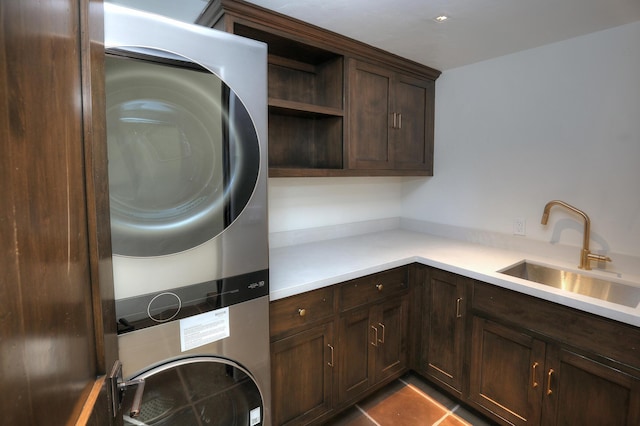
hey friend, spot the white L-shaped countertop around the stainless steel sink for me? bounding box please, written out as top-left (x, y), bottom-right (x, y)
top-left (269, 229), bottom-right (640, 327)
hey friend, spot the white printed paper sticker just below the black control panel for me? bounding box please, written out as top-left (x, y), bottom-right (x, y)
top-left (180, 308), bottom-right (230, 352)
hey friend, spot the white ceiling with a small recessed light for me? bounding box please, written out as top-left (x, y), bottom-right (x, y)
top-left (111, 0), bottom-right (640, 71)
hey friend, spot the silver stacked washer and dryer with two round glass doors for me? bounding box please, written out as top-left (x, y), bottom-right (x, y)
top-left (105, 3), bottom-right (271, 426)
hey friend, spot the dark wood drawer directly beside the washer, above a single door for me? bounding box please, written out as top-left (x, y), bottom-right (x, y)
top-left (269, 287), bottom-right (333, 337)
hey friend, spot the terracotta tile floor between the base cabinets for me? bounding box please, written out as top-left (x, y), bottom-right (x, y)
top-left (327, 373), bottom-right (493, 426)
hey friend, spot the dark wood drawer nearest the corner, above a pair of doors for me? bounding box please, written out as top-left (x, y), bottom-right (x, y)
top-left (339, 267), bottom-right (409, 311)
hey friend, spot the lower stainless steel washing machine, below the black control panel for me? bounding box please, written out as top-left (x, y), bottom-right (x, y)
top-left (118, 292), bottom-right (271, 426)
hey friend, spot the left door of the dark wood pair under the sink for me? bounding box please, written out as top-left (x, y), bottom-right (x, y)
top-left (469, 317), bottom-right (545, 425)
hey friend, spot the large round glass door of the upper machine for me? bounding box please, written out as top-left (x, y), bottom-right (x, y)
top-left (105, 49), bottom-right (260, 257)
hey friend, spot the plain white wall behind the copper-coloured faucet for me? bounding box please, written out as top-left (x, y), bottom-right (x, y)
top-left (402, 22), bottom-right (640, 256)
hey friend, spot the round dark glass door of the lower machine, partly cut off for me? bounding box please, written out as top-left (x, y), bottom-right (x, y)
top-left (123, 357), bottom-right (264, 426)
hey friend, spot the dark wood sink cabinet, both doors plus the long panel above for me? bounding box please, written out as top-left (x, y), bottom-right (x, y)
top-left (469, 282), bottom-right (640, 426)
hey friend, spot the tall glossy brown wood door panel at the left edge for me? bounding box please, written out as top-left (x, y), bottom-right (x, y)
top-left (0, 0), bottom-right (115, 425)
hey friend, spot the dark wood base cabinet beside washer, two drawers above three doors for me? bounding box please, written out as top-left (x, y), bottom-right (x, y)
top-left (269, 267), bottom-right (409, 425)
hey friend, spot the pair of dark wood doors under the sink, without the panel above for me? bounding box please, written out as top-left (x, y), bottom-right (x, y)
top-left (469, 317), bottom-right (640, 426)
